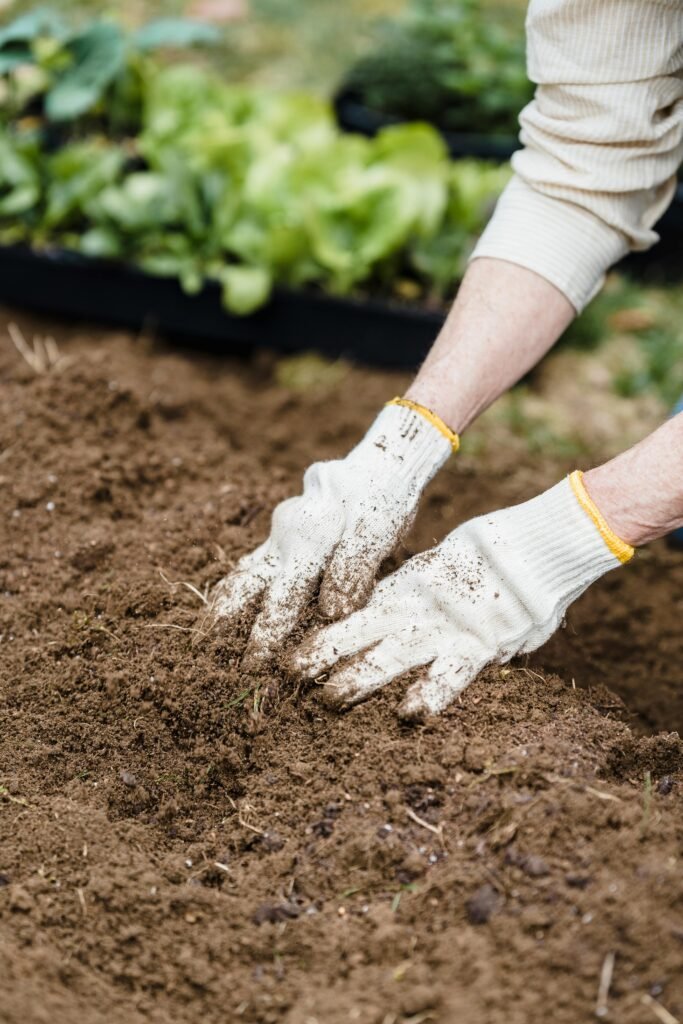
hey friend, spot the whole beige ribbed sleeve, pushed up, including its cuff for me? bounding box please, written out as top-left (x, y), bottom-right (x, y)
top-left (472, 0), bottom-right (683, 310)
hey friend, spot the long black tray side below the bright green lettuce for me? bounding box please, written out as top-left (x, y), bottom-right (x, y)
top-left (0, 246), bottom-right (443, 369)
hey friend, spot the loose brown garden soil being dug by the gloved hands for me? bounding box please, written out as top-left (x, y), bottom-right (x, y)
top-left (0, 316), bottom-right (683, 1024)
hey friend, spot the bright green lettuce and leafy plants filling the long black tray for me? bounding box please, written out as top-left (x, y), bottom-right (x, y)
top-left (0, 38), bottom-right (509, 314)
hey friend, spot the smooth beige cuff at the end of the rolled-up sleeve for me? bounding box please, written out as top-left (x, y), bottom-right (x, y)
top-left (471, 176), bottom-right (629, 312)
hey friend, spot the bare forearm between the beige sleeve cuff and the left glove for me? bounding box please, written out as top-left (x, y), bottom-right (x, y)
top-left (407, 259), bottom-right (573, 433)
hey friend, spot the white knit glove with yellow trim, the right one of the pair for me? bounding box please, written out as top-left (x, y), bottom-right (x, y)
top-left (292, 472), bottom-right (633, 719)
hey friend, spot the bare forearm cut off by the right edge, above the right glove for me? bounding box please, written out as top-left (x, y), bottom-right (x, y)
top-left (584, 414), bottom-right (683, 547)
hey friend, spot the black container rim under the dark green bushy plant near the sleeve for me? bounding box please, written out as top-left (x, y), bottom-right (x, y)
top-left (333, 89), bottom-right (519, 163)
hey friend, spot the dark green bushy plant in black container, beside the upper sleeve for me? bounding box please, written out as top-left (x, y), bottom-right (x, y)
top-left (343, 0), bottom-right (532, 134)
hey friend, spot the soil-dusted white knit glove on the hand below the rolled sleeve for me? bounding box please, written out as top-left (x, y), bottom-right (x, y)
top-left (212, 398), bottom-right (458, 670)
